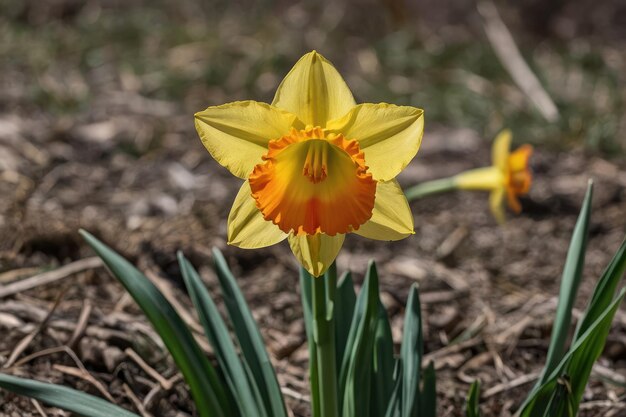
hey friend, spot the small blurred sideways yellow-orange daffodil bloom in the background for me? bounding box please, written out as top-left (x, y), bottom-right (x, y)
top-left (454, 129), bottom-right (533, 223)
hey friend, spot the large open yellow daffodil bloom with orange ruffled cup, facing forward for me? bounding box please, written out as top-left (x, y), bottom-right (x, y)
top-left (195, 51), bottom-right (424, 276)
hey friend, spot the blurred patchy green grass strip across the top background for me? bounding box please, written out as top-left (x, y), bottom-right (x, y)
top-left (0, 0), bottom-right (626, 156)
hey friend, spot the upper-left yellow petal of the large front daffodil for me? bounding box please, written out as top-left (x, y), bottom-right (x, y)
top-left (195, 101), bottom-right (297, 179)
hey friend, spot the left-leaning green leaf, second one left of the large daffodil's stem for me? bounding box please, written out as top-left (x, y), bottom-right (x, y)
top-left (213, 248), bottom-right (287, 417)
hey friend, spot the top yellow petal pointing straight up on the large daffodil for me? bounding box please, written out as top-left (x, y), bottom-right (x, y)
top-left (272, 51), bottom-right (356, 127)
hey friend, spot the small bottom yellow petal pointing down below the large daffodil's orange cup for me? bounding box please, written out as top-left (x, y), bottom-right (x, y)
top-left (289, 233), bottom-right (345, 277)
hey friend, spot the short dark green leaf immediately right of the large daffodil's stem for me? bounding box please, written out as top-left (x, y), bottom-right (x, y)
top-left (335, 272), bottom-right (356, 378)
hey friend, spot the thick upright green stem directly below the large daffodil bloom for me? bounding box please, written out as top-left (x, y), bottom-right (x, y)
top-left (312, 263), bottom-right (339, 417)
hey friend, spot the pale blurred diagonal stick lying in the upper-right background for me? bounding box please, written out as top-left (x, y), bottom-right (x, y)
top-left (478, 0), bottom-right (559, 122)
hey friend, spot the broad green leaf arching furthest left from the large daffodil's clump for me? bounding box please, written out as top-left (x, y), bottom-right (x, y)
top-left (80, 230), bottom-right (228, 417)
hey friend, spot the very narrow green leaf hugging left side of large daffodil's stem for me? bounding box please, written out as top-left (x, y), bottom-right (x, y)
top-left (300, 268), bottom-right (320, 417)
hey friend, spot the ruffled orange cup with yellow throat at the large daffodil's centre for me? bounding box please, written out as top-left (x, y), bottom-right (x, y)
top-left (248, 127), bottom-right (376, 236)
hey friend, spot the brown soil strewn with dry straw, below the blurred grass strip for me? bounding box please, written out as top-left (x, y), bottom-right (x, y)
top-left (0, 1), bottom-right (626, 417)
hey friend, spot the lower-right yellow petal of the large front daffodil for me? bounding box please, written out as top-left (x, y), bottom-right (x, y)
top-left (354, 180), bottom-right (415, 240)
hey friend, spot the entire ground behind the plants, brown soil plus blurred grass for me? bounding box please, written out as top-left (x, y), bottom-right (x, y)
top-left (0, 0), bottom-right (626, 417)
